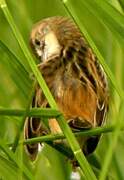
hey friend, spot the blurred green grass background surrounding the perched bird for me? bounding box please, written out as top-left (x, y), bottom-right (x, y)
top-left (0, 0), bottom-right (124, 180)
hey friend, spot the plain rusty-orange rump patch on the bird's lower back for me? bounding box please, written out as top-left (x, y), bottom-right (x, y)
top-left (51, 75), bottom-right (97, 126)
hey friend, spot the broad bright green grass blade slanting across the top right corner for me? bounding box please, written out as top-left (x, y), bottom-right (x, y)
top-left (82, 0), bottom-right (124, 42)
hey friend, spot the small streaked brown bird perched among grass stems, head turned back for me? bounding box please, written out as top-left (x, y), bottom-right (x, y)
top-left (25, 16), bottom-right (108, 160)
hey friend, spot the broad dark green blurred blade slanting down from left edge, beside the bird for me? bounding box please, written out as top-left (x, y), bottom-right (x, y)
top-left (0, 40), bottom-right (31, 97)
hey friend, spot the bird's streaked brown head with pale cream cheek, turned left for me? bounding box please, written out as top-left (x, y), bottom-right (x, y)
top-left (30, 16), bottom-right (81, 62)
